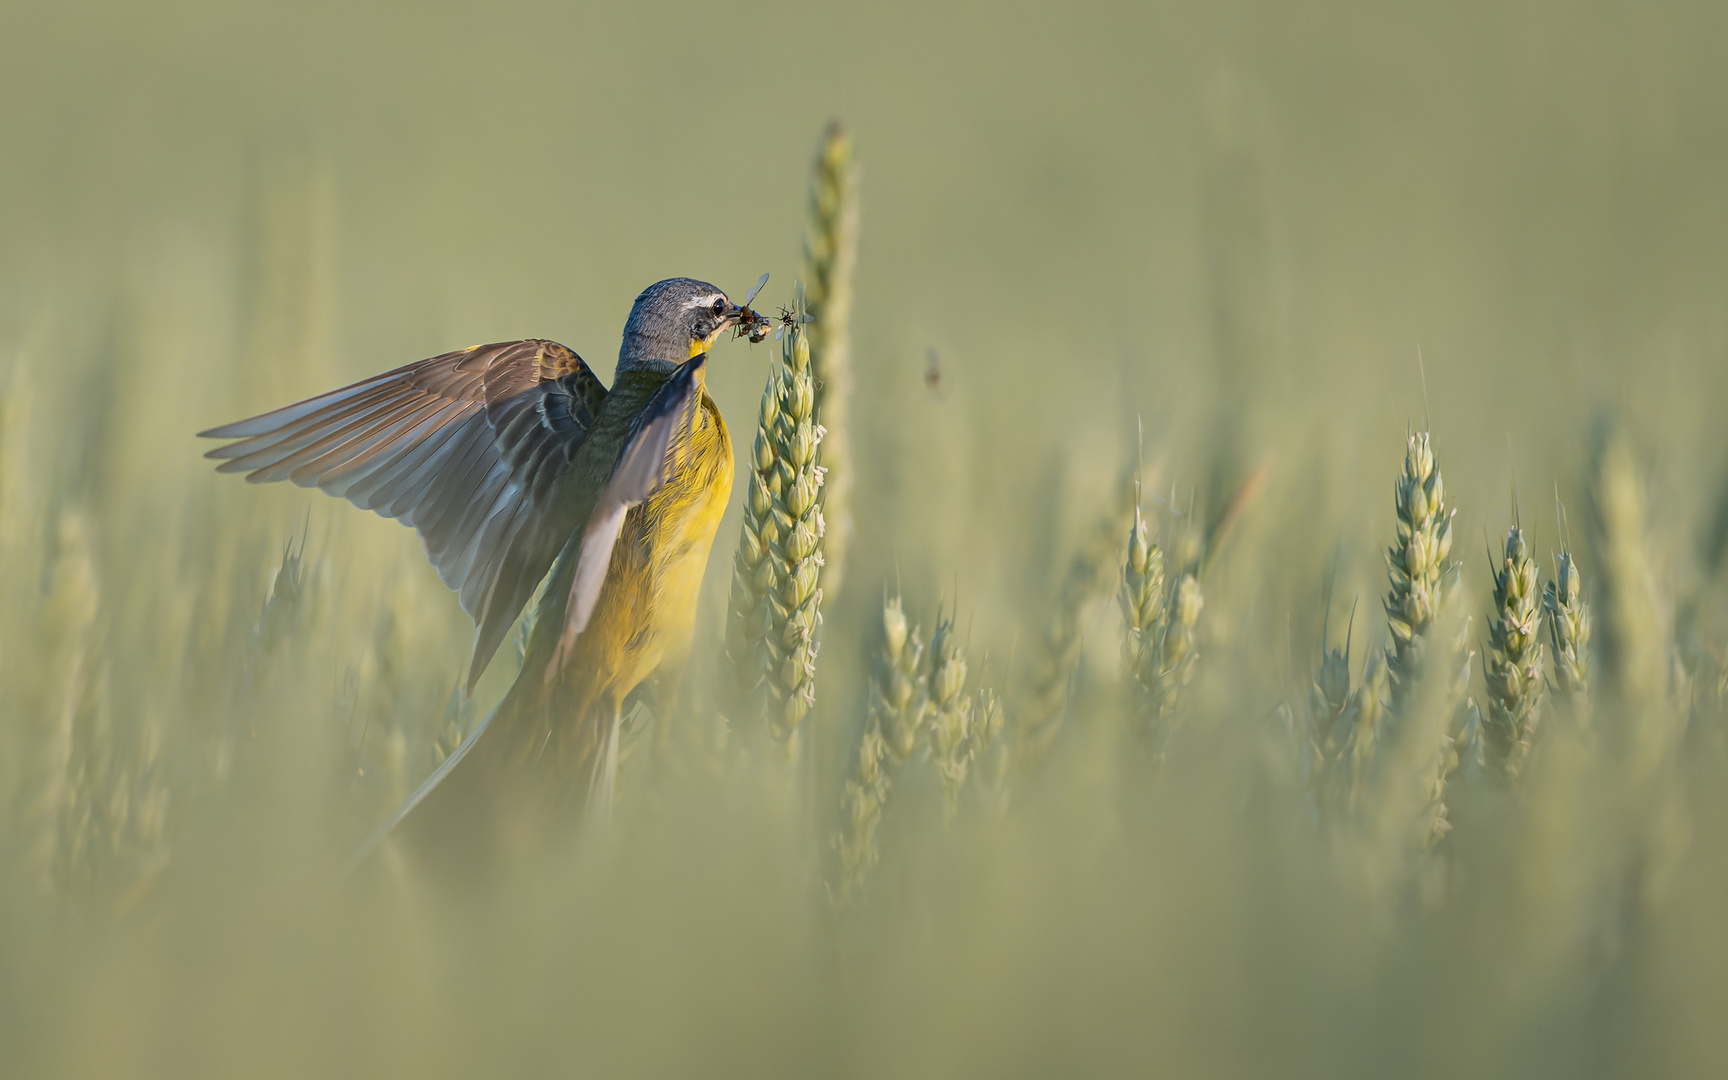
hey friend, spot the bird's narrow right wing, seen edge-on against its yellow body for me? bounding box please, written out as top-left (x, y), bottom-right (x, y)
top-left (548, 354), bottom-right (708, 660)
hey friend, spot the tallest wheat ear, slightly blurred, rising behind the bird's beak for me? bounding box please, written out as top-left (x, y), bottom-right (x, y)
top-left (804, 121), bottom-right (859, 593)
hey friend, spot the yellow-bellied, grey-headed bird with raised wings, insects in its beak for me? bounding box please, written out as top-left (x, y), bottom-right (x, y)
top-left (200, 275), bottom-right (767, 857)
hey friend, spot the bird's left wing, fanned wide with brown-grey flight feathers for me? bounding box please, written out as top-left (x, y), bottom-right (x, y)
top-left (199, 340), bottom-right (607, 691)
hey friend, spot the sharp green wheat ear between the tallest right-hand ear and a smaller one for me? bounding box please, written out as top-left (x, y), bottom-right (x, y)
top-left (1481, 524), bottom-right (1543, 781)
